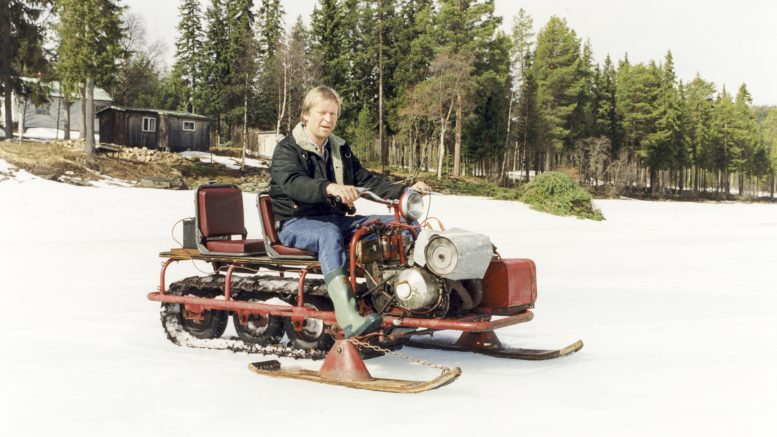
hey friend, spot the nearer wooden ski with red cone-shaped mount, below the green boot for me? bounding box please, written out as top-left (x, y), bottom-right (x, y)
top-left (248, 340), bottom-right (461, 393)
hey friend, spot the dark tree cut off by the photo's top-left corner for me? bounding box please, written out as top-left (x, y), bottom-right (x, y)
top-left (0, 0), bottom-right (50, 139)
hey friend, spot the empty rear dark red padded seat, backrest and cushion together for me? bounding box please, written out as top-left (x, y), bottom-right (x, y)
top-left (195, 184), bottom-right (265, 256)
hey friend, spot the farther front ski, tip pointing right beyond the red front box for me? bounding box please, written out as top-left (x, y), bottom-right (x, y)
top-left (407, 331), bottom-right (583, 361)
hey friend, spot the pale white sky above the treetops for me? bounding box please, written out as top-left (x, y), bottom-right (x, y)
top-left (124, 0), bottom-right (777, 105)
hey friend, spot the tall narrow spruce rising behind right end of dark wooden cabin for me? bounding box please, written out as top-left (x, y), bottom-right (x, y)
top-left (173, 0), bottom-right (205, 113)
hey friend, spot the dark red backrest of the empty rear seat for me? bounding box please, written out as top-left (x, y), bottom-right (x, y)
top-left (196, 185), bottom-right (246, 239)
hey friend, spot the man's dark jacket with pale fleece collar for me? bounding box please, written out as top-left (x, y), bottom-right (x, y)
top-left (270, 124), bottom-right (405, 222)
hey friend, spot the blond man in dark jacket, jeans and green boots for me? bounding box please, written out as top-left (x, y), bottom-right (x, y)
top-left (270, 86), bottom-right (430, 338)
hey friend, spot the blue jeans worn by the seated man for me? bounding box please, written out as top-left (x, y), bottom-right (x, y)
top-left (278, 215), bottom-right (394, 276)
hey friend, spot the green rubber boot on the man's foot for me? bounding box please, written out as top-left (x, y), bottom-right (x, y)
top-left (324, 270), bottom-right (383, 338)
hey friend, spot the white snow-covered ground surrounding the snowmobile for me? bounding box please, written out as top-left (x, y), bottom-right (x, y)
top-left (0, 161), bottom-right (777, 436)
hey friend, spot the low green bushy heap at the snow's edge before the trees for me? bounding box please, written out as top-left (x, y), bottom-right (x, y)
top-left (520, 172), bottom-right (604, 220)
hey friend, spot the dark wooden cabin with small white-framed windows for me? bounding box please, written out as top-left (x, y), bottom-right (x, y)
top-left (97, 106), bottom-right (210, 152)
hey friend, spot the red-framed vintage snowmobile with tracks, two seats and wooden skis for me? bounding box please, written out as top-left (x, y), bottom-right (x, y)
top-left (148, 184), bottom-right (583, 392)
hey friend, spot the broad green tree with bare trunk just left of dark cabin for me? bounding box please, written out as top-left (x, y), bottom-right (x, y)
top-left (56, 0), bottom-right (125, 153)
